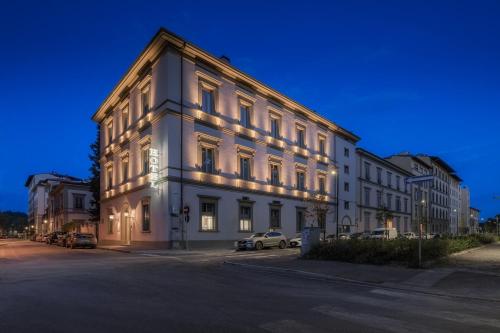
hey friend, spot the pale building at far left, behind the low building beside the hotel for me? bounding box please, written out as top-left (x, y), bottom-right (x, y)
top-left (24, 172), bottom-right (80, 234)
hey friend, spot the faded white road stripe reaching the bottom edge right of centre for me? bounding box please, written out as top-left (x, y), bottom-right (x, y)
top-left (312, 305), bottom-right (442, 333)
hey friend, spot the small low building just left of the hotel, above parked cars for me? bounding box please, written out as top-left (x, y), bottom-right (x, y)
top-left (47, 180), bottom-right (96, 234)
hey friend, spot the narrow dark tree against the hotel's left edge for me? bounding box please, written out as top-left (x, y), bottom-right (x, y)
top-left (89, 125), bottom-right (101, 237)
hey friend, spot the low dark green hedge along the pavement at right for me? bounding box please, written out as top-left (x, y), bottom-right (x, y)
top-left (306, 235), bottom-right (496, 267)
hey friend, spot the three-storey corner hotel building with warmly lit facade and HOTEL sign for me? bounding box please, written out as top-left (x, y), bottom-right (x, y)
top-left (93, 29), bottom-right (359, 246)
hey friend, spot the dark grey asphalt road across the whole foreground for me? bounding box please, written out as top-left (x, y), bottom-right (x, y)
top-left (0, 241), bottom-right (500, 333)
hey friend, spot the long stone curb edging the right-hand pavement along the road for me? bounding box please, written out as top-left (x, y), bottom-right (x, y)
top-left (224, 261), bottom-right (500, 303)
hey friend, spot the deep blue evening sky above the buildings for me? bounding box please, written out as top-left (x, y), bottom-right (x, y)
top-left (0, 1), bottom-right (500, 216)
